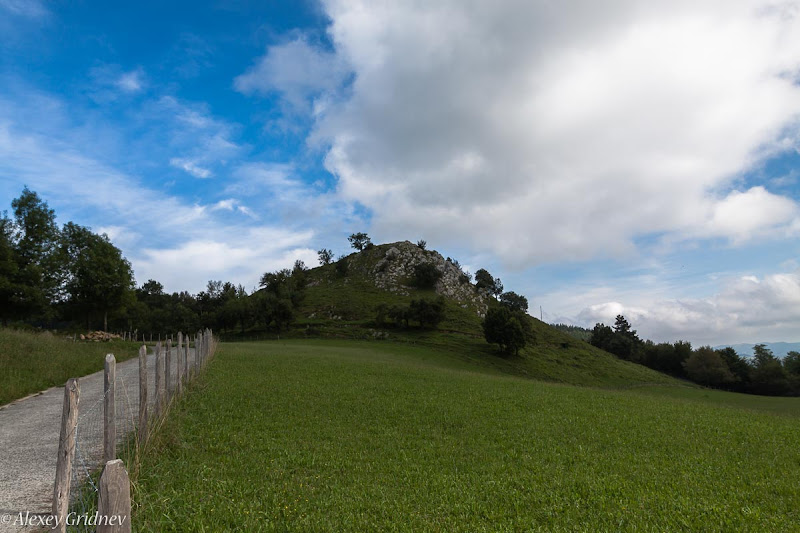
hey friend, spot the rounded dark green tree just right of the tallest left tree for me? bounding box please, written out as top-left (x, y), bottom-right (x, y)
top-left (63, 222), bottom-right (134, 331)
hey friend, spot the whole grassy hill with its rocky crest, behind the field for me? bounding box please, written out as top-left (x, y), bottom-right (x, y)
top-left (248, 241), bottom-right (690, 387)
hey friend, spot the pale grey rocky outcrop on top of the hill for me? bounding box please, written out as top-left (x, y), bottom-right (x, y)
top-left (371, 241), bottom-right (488, 317)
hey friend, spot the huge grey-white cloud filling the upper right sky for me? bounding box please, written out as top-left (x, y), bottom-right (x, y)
top-left (290, 0), bottom-right (800, 267)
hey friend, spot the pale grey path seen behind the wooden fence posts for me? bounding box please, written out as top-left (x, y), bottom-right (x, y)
top-left (0, 342), bottom-right (194, 533)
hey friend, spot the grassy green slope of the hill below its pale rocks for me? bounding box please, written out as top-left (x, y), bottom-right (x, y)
top-left (253, 244), bottom-right (693, 387)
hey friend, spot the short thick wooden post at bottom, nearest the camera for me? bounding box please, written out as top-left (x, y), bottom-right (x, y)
top-left (97, 459), bottom-right (131, 533)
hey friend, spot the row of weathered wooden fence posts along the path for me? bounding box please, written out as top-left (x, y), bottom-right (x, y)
top-left (53, 329), bottom-right (216, 533)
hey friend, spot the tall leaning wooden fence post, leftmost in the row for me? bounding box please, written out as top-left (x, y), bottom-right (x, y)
top-left (53, 378), bottom-right (81, 533)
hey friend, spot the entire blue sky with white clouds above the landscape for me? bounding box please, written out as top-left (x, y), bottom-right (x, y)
top-left (0, 0), bottom-right (800, 344)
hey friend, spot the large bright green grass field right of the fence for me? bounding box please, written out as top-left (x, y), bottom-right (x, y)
top-left (133, 341), bottom-right (800, 531)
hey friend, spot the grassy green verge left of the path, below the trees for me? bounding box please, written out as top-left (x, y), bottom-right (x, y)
top-left (0, 328), bottom-right (139, 405)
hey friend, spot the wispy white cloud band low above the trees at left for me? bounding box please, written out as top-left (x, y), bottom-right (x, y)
top-left (0, 121), bottom-right (316, 291)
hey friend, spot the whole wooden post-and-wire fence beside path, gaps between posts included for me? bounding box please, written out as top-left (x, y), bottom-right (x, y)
top-left (52, 330), bottom-right (216, 532)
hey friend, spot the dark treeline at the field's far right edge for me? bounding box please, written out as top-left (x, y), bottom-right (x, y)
top-left (589, 315), bottom-right (800, 396)
